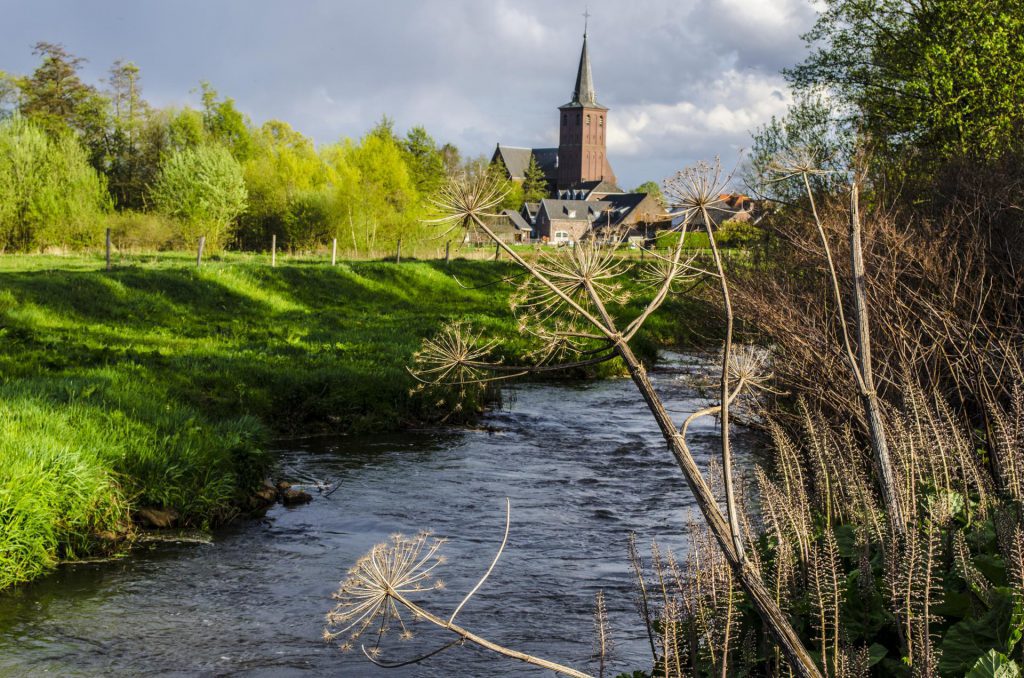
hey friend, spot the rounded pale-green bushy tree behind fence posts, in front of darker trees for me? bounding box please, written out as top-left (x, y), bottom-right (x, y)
top-left (153, 144), bottom-right (248, 249)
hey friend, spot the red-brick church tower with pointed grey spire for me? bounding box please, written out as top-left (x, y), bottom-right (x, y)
top-left (558, 32), bottom-right (615, 190)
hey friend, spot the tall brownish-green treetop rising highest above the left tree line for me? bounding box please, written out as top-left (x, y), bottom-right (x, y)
top-left (19, 42), bottom-right (110, 171)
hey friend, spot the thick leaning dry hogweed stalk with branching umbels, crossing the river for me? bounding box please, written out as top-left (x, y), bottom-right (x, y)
top-left (415, 162), bottom-right (820, 676)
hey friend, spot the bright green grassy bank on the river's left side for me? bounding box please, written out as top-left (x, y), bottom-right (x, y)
top-left (0, 257), bottom-right (716, 588)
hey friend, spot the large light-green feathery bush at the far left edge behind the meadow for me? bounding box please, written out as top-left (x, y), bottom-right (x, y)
top-left (0, 117), bottom-right (109, 251)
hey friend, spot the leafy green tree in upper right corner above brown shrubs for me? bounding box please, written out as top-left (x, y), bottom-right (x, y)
top-left (785, 0), bottom-right (1024, 161)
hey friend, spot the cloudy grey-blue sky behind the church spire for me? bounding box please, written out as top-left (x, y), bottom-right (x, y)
top-left (0, 0), bottom-right (816, 189)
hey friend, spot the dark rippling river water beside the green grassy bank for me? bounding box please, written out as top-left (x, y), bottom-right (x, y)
top-left (0, 355), bottom-right (756, 676)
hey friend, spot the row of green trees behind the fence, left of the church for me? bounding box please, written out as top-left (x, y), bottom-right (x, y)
top-left (0, 42), bottom-right (547, 252)
